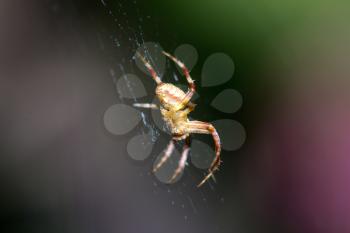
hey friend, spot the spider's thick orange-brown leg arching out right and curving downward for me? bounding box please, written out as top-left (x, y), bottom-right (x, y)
top-left (187, 121), bottom-right (221, 187)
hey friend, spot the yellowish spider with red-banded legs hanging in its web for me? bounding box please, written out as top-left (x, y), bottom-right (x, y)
top-left (134, 51), bottom-right (221, 187)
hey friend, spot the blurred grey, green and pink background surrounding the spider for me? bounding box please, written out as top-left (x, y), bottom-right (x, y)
top-left (0, 0), bottom-right (350, 233)
